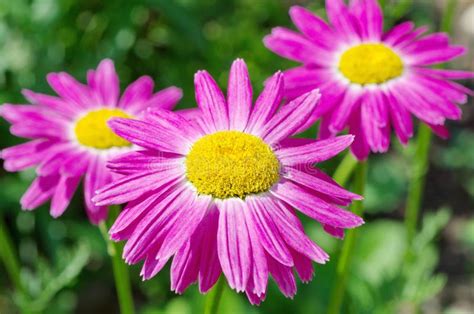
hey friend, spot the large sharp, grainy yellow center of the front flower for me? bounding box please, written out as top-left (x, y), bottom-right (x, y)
top-left (186, 131), bottom-right (280, 199)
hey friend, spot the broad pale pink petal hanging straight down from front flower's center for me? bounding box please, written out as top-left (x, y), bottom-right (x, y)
top-left (217, 199), bottom-right (251, 292)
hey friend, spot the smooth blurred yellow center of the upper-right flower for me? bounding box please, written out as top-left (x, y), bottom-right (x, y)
top-left (339, 44), bottom-right (403, 85)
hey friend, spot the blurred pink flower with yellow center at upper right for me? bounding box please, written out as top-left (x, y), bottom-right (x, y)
top-left (264, 0), bottom-right (474, 159)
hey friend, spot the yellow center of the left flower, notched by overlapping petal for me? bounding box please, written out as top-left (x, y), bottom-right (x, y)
top-left (74, 109), bottom-right (132, 149)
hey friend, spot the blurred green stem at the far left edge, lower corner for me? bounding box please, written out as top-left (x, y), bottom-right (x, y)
top-left (0, 217), bottom-right (25, 293)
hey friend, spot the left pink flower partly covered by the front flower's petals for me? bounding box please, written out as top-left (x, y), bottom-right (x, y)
top-left (0, 60), bottom-right (181, 223)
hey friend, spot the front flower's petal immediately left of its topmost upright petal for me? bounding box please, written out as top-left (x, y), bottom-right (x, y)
top-left (194, 71), bottom-right (229, 131)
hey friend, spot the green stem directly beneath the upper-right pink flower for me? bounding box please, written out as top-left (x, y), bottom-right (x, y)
top-left (328, 162), bottom-right (367, 314)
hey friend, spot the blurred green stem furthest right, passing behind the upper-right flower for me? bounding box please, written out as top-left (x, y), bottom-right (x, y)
top-left (405, 0), bottom-right (457, 247)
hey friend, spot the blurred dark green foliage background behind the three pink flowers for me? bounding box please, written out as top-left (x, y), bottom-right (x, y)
top-left (0, 0), bottom-right (474, 314)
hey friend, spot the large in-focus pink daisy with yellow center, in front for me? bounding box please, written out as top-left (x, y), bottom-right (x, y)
top-left (93, 59), bottom-right (363, 304)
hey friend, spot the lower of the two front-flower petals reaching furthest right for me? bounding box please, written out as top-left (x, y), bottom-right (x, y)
top-left (270, 181), bottom-right (364, 228)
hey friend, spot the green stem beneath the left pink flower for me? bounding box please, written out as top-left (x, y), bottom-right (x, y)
top-left (99, 206), bottom-right (135, 314)
